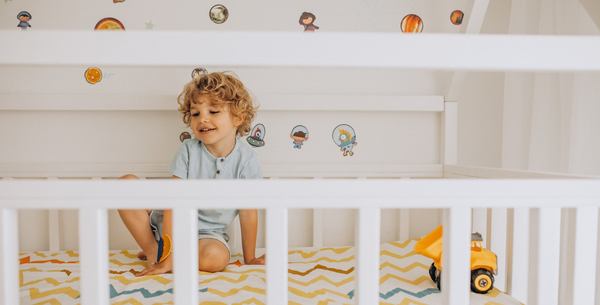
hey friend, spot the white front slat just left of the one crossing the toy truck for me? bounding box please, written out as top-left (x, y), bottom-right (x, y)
top-left (355, 208), bottom-right (381, 304)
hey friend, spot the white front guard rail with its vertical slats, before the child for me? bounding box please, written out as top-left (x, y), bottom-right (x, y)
top-left (0, 179), bottom-right (600, 305)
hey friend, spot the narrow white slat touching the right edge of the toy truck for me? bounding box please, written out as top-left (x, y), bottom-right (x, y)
top-left (490, 208), bottom-right (508, 291)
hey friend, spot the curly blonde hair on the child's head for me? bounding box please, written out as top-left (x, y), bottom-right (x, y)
top-left (177, 72), bottom-right (256, 136)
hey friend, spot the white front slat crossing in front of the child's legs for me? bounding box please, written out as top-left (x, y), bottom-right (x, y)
top-left (172, 208), bottom-right (198, 305)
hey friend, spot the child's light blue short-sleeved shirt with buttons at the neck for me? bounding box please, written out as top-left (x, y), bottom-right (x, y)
top-left (150, 139), bottom-right (262, 240)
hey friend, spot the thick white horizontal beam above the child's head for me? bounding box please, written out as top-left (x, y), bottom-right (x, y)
top-left (0, 31), bottom-right (600, 71)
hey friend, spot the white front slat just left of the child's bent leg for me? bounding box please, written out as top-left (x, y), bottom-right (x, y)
top-left (79, 207), bottom-right (109, 305)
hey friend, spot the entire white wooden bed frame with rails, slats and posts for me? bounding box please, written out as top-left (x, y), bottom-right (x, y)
top-left (0, 31), bottom-right (600, 305)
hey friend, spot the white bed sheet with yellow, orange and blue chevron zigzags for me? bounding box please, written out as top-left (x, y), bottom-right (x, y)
top-left (19, 241), bottom-right (521, 305)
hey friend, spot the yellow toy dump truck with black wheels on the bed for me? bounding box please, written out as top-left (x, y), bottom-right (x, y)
top-left (415, 226), bottom-right (497, 293)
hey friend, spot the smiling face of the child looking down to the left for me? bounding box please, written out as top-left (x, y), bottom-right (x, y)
top-left (190, 95), bottom-right (240, 157)
